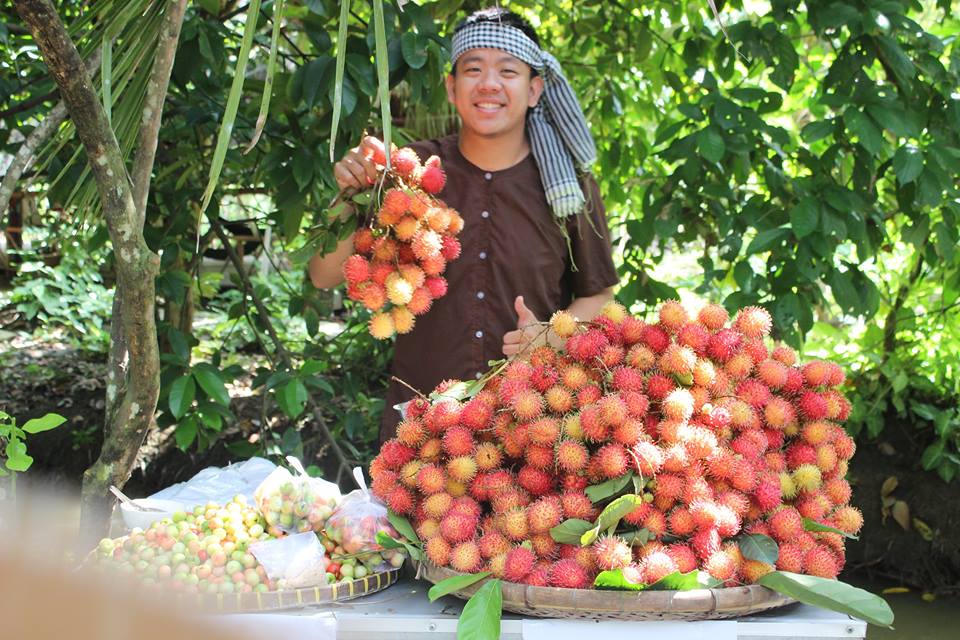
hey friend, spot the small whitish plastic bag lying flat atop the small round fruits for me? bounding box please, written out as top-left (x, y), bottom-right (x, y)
top-left (248, 531), bottom-right (328, 590)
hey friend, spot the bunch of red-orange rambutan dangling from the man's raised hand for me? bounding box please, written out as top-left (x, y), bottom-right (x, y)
top-left (343, 149), bottom-right (463, 340)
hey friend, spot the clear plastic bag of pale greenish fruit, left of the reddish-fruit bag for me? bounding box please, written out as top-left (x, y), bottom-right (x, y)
top-left (254, 456), bottom-right (341, 536)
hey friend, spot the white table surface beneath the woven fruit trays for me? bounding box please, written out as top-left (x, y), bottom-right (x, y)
top-left (231, 577), bottom-right (867, 640)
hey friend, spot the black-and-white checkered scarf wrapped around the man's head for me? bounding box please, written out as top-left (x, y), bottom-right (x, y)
top-left (451, 22), bottom-right (597, 218)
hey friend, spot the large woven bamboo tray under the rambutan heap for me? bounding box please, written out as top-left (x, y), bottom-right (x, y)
top-left (420, 562), bottom-right (796, 620)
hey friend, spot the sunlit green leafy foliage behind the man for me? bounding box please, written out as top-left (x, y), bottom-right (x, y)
top-left (0, 0), bottom-right (960, 481)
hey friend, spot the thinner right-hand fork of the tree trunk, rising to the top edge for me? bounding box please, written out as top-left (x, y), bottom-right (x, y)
top-left (130, 0), bottom-right (187, 220)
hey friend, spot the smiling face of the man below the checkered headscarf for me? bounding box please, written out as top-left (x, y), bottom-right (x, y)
top-left (447, 49), bottom-right (543, 137)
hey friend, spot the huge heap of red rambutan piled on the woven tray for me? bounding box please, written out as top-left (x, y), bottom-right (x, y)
top-left (370, 301), bottom-right (863, 588)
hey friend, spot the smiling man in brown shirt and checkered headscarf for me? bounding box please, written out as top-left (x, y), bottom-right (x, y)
top-left (310, 9), bottom-right (617, 439)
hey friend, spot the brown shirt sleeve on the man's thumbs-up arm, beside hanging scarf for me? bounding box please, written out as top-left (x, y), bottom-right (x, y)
top-left (567, 175), bottom-right (620, 298)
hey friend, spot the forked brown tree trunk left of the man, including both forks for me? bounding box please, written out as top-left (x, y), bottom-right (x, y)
top-left (14, 0), bottom-right (186, 546)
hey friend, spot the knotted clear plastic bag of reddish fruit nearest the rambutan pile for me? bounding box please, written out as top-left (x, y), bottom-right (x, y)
top-left (325, 467), bottom-right (403, 569)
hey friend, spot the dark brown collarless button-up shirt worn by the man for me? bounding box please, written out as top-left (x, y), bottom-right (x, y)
top-left (380, 135), bottom-right (618, 440)
